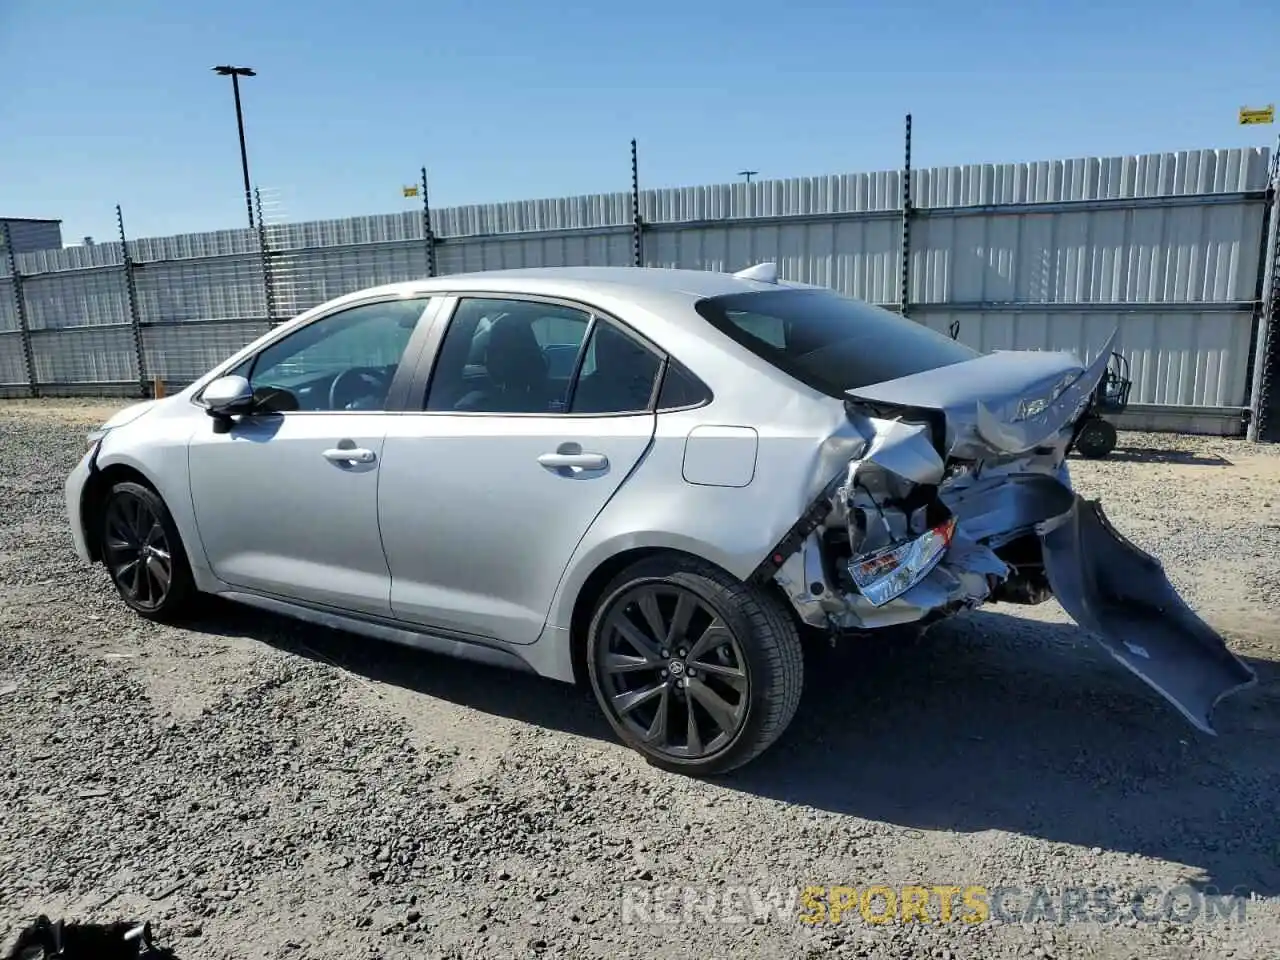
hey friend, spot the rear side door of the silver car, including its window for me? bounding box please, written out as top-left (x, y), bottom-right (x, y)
top-left (378, 294), bottom-right (662, 644)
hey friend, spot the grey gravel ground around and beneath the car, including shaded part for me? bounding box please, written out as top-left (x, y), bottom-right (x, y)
top-left (0, 401), bottom-right (1280, 960)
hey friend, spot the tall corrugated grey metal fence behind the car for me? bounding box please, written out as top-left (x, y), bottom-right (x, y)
top-left (0, 148), bottom-right (1277, 433)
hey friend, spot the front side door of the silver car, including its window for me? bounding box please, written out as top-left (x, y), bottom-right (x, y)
top-left (188, 298), bottom-right (426, 616)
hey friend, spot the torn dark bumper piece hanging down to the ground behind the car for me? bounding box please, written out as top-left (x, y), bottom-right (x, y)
top-left (1039, 495), bottom-right (1257, 733)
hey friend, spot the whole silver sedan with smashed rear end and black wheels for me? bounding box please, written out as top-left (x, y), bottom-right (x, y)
top-left (67, 265), bottom-right (1253, 774)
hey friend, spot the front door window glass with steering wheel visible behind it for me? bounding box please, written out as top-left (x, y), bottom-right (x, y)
top-left (243, 297), bottom-right (429, 411)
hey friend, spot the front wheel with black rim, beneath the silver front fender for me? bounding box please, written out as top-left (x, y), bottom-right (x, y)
top-left (100, 480), bottom-right (196, 622)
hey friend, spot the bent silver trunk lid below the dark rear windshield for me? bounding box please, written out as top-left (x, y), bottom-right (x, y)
top-left (846, 333), bottom-right (1116, 457)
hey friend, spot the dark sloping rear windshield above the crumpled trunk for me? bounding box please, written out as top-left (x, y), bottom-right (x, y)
top-left (696, 289), bottom-right (980, 397)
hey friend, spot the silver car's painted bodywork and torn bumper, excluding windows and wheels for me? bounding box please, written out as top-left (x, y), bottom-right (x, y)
top-left (65, 268), bottom-right (1248, 730)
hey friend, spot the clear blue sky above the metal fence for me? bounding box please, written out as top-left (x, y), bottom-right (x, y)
top-left (0, 0), bottom-right (1280, 241)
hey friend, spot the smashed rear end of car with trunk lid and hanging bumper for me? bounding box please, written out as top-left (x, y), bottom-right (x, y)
top-left (758, 334), bottom-right (1254, 732)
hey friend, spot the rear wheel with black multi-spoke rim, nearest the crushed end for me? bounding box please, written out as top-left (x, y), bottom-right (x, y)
top-left (586, 556), bottom-right (804, 776)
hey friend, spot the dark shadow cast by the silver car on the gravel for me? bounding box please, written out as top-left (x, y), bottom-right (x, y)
top-left (186, 611), bottom-right (1280, 896)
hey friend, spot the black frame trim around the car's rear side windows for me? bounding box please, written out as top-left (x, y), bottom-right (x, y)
top-left (406, 288), bottom-right (712, 420)
